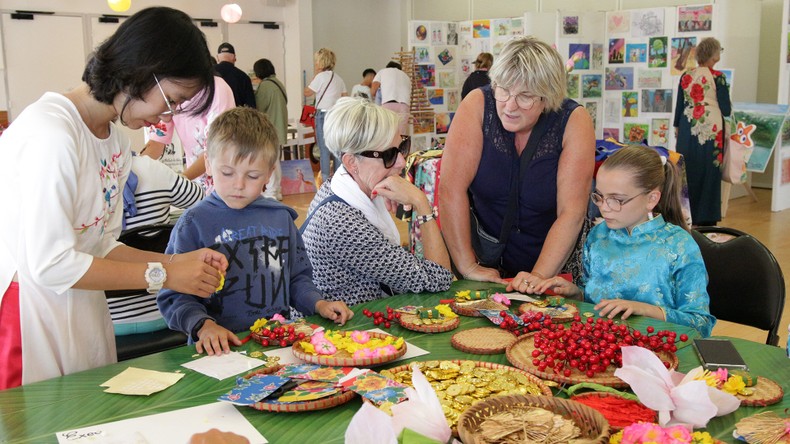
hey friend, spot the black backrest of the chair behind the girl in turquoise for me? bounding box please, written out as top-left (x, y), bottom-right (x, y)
top-left (691, 227), bottom-right (785, 345)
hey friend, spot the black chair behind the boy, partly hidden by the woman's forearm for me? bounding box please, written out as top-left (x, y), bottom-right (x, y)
top-left (105, 224), bottom-right (187, 361)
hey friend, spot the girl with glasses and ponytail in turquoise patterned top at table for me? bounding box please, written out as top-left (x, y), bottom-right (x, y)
top-left (532, 145), bottom-right (716, 337)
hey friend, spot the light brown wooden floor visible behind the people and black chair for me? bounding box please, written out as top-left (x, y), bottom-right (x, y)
top-left (283, 189), bottom-right (790, 347)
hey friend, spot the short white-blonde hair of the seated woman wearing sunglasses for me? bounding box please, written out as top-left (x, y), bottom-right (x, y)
top-left (324, 97), bottom-right (400, 158)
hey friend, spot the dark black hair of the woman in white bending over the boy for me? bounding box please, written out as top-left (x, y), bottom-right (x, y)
top-left (83, 7), bottom-right (214, 115)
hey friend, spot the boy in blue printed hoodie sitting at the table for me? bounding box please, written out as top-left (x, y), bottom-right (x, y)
top-left (157, 107), bottom-right (353, 355)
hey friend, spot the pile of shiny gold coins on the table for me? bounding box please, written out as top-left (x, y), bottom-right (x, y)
top-left (380, 361), bottom-right (542, 427)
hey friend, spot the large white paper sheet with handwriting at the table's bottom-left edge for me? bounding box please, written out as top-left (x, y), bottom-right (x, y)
top-left (55, 402), bottom-right (268, 444)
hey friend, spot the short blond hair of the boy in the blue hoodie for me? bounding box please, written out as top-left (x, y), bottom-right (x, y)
top-left (206, 106), bottom-right (280, 168)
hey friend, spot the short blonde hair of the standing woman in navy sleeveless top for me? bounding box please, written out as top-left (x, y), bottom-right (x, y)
top-left (488, 36), bottom-right (567, 113)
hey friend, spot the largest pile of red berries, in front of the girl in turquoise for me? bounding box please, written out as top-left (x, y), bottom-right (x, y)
top-left (532, 315), bottom-right (688, 378)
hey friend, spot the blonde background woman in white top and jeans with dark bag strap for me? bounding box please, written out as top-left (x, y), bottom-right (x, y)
top-left (304, 48), bottom-right (348, 180)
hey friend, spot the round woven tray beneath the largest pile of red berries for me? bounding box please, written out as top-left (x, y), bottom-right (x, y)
top-left (505, 333), bottom-right (678, 388)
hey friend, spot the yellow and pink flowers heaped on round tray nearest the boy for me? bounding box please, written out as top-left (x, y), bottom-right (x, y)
top-left (302, 329), bottom-right (404, 359)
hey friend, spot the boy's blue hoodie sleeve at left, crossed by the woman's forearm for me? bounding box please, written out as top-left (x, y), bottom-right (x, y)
top-left (156, 210), bottom-right (214, 343)
